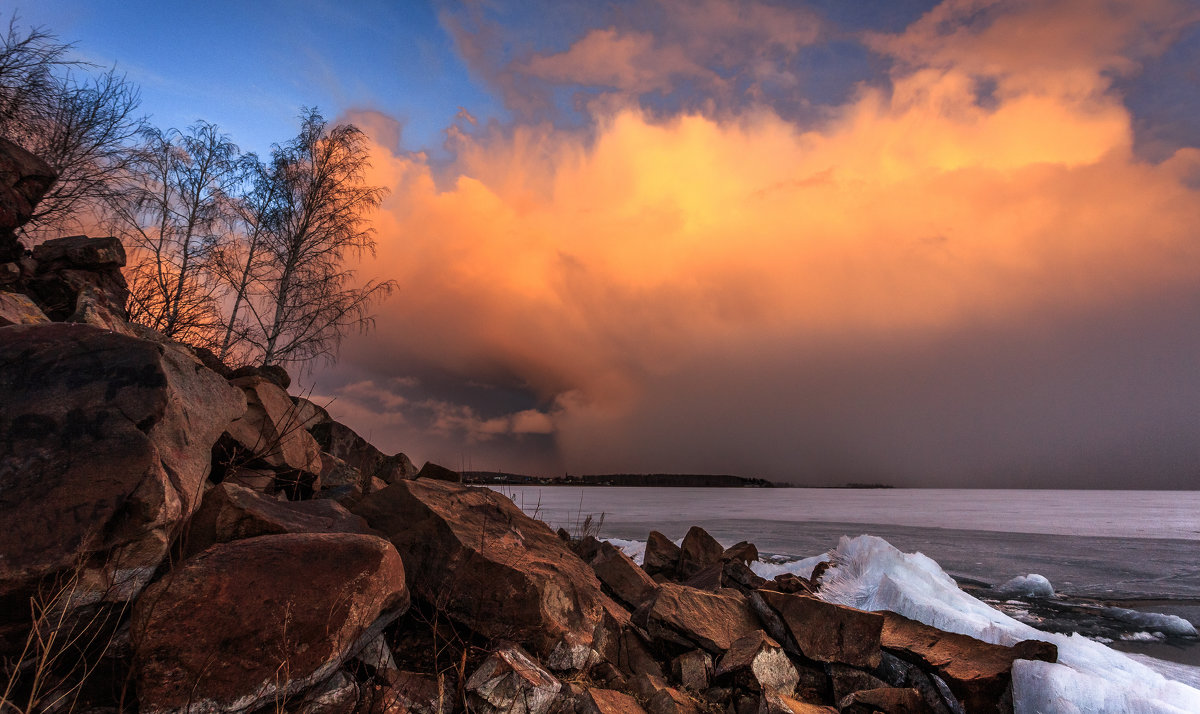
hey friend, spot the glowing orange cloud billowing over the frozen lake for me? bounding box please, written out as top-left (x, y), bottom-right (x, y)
top-left (326, 0), bottom-right (1200, 487)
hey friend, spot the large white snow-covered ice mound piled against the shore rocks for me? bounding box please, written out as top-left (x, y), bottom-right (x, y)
top-left (820, 535), bottom-right (1200, 714)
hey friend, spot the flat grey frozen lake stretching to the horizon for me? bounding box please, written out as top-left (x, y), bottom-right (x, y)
top-left (497, 486), bottom-right (1200, 600)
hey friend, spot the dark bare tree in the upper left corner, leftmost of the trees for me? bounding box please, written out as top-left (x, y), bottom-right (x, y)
top-left (0, 16), bottom-right (144, 236)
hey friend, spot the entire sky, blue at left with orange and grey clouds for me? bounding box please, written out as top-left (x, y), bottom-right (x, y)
top-left (14, 0), bottom-right (1200, 488)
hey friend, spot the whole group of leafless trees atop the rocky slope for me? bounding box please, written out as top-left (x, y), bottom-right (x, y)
top-left (0, 17), bottom-right (395, 365)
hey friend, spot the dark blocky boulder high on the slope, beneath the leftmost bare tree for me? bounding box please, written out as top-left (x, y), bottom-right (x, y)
top-left (26, 235), bottom-right (128, 330)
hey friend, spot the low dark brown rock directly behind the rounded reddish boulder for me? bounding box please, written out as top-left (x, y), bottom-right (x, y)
top-left (182, 482), bottom-right (371, 558)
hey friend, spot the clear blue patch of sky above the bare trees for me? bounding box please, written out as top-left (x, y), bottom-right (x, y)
top-left (16, 0), bottom-right (504, 152)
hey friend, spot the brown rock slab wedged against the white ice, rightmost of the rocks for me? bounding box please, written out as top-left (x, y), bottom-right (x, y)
top-left (882, 612), bottom-right (1058, 712)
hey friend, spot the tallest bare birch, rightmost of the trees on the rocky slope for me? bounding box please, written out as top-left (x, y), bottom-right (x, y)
top-left (234, 109), bottom-right (395, 365)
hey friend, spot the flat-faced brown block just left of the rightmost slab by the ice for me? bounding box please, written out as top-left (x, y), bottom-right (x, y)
top-left (760, 590), bottom-right (883, 668)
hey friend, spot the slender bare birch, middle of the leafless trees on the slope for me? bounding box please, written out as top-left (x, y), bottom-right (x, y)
top-left (113, 121), bottom-right (241, 346)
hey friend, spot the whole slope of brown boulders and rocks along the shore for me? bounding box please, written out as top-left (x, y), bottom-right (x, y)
top-left (0, 140), bottom-right (1057, 714)
